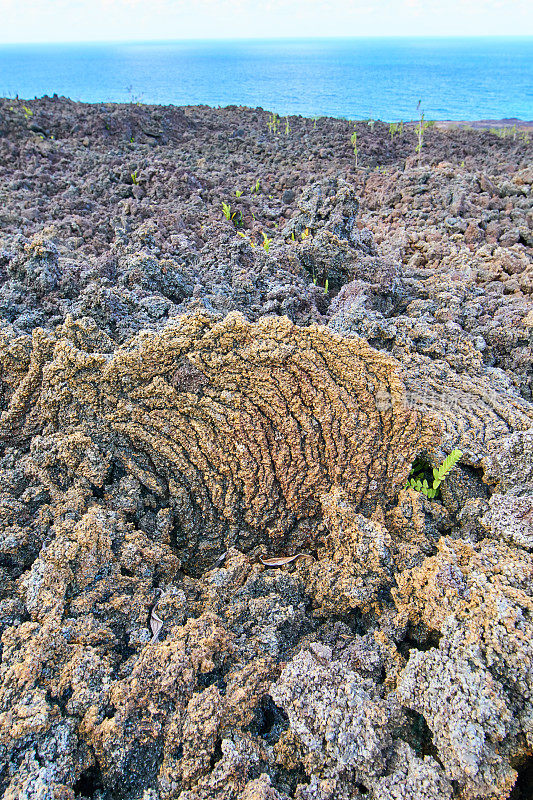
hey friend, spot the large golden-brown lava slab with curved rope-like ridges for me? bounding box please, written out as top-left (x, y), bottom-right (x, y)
top-left (0, 314), bottom-right (436, 571)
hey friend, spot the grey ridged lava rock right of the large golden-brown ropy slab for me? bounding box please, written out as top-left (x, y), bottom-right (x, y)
top-left (329, 282), bottom-right (533, 466)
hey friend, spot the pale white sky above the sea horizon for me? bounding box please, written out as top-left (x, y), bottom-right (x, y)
top-left (0, 0), bottom-right (533, 44)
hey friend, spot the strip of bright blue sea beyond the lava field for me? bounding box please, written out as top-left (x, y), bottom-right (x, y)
top-left (0, 37), bottom-right (533, 121)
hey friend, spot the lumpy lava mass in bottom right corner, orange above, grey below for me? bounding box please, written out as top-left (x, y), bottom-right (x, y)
top-left (393, 538), bottom-right (533, 799)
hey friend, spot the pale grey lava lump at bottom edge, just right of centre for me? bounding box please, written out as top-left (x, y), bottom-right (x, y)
top-left (272, 642), bottom-right (452, 800)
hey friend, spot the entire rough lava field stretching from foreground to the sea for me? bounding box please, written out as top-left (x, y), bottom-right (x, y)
top-left (0, 97), bottom-right (533, 800)
